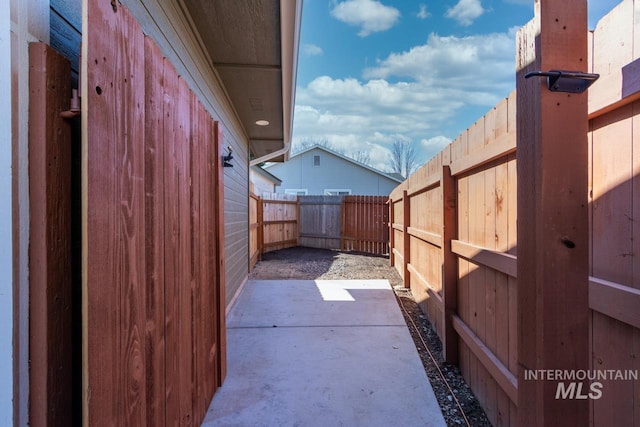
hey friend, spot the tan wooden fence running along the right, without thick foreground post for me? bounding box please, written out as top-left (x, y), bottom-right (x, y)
top-left (390, 0), bottom-right (640, 426)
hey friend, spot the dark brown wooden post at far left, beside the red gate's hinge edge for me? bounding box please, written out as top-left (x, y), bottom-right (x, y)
top-left (29, 43), bottom-right (73, 427)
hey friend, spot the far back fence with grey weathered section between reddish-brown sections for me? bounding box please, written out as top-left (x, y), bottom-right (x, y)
top-left (249, 193), bottom-right (389, 267)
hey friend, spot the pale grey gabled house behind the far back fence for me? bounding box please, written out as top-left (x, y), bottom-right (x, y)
top-left (265, 145), bottom-right (403, 196)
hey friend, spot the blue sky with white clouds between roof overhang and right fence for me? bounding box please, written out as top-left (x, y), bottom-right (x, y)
top-left (293, 0), bottom-right (619, 170)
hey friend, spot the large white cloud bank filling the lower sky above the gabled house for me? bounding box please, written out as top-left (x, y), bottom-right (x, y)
top-left (293, 33), bottom-right (515, 170)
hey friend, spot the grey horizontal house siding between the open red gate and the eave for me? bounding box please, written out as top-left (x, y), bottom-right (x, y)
top-left (123, 0), bottom-right (249, 304)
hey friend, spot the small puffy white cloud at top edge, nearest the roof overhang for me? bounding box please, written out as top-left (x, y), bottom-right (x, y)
top-left (331, 0), bottom-right (400, 37)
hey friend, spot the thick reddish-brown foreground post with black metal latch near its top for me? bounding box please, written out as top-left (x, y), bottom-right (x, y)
top-left (516, 0), bottom-right (591, 426)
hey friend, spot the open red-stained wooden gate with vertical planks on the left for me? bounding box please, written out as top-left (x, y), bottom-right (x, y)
top-left (81, 0), bottom-right (225, 425)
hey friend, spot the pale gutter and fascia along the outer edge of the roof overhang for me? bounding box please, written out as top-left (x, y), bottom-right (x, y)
top-left (249, 0), bottom-right (303, 166)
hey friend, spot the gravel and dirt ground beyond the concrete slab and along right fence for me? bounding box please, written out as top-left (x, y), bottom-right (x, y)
top-left (249, 247), bottom-right (491, 427)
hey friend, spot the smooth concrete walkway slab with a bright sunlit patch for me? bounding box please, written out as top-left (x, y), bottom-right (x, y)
top-left (202, 280), bottom-right (445, 426)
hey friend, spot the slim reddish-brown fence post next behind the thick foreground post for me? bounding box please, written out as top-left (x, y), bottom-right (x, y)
top-left (440, 165), bottom-right (458, 365)
